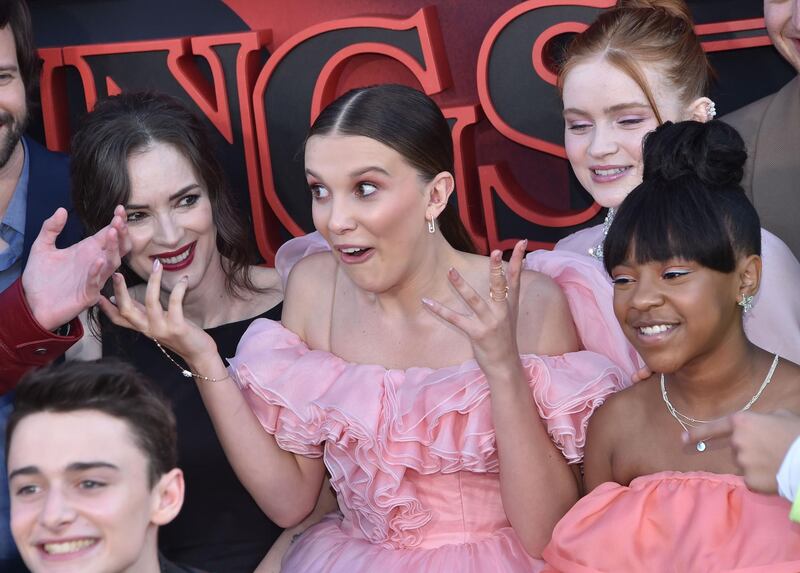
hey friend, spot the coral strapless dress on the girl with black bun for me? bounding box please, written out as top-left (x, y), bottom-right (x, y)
top-left (544, 472), bottom-right (800, 573)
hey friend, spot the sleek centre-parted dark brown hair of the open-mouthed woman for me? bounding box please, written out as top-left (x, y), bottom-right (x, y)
top-left (306, 84), bottom-right (476, 253)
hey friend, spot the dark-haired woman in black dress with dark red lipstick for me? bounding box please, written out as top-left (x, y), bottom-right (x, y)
top-left (71, 93), bottom-right (306, 573)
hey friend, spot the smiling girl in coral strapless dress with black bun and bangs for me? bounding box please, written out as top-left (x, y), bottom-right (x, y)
top-left (544, 121), bottom-right (800, 573)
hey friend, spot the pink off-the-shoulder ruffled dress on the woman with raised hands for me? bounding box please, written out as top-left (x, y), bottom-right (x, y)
top-left (230, 319), bottom-right (623, 573)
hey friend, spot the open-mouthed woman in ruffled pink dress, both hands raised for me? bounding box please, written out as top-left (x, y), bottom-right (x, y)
top-left (104, 85), bottom-right (622, 573)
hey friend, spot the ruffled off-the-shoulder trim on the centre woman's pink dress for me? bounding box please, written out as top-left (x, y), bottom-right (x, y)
top-left (230, 319), bottom-right (623, 547)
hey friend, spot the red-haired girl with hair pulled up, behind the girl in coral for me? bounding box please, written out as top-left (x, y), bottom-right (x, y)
top-left (526, 0), bottom-right (800, 375)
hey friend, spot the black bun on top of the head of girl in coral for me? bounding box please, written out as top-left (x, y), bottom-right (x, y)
top-left (643, 121), bottom-right (747, 188)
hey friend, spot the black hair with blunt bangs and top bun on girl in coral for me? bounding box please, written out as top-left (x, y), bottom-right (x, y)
top-left (603, 121), bottom-right (761, 274)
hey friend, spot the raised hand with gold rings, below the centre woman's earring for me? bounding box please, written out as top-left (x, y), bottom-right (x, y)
top-left (423, 241), bottom-right (528, 374)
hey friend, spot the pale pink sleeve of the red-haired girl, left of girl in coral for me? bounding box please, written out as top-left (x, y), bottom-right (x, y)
top-left (525, 250), bottom-right (644, 379)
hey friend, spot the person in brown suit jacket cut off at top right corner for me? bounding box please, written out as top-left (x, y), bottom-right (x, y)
top-left (722, 0), bottom-right (800, 258)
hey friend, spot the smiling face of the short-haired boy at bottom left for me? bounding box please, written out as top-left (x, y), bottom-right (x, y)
top-left (8, 410), bottom-right (162, 573)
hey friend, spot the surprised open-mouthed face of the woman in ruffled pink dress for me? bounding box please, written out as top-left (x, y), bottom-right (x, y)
top-left (305, 135), bottom-right (427, 292)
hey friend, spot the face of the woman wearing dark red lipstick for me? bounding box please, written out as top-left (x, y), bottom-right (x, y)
top-left (125, 142), bottom-right (220, 291)
